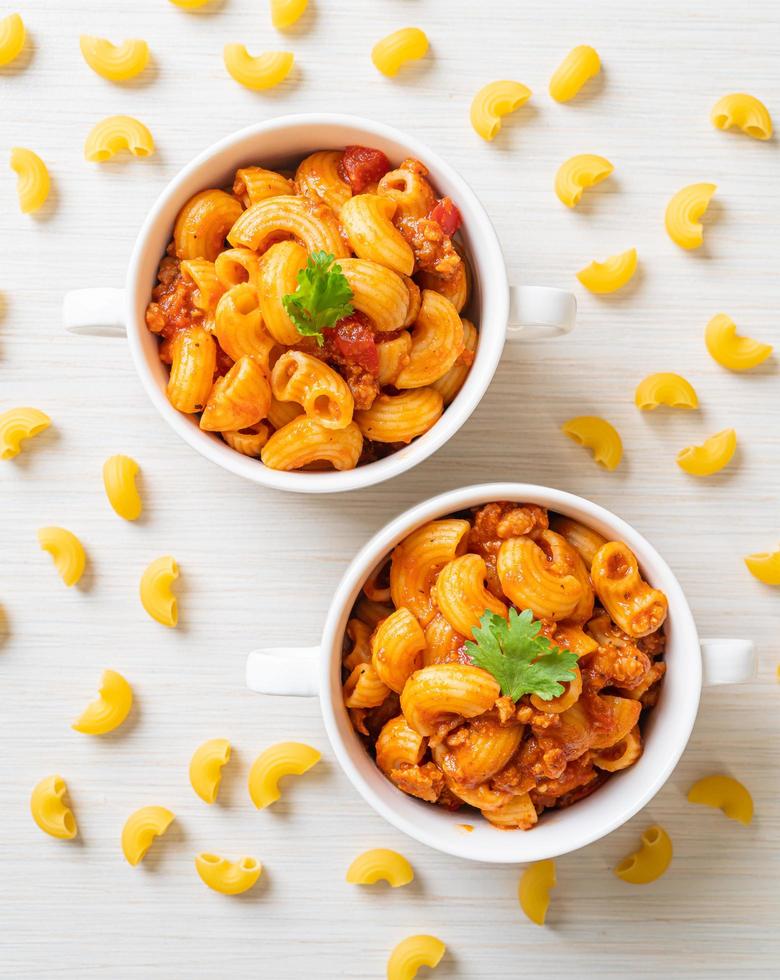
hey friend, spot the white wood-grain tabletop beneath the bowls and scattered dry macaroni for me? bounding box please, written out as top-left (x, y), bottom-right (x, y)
top-left (0, 0), bottom-right (780, 980)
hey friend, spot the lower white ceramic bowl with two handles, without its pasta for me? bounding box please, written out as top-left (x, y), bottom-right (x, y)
top-left (247, 483), bottom-right (755, 863)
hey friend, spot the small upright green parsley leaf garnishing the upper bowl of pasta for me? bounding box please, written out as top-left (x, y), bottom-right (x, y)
top-left (282, 252), bottom-right (353, 347)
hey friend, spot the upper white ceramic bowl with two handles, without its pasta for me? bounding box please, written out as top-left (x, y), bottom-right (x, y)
top-left (63, 113), bottom-right (576, 493)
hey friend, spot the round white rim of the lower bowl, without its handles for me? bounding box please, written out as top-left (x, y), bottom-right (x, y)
top-left (320, 482), bottom-right (702, 864)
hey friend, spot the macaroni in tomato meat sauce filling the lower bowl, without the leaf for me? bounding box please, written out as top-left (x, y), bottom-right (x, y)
top-left (343, 502), bottom-right (667, 830)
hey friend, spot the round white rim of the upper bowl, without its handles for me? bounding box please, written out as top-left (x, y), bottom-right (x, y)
top-left (126, 112), bottom-right (509, 493)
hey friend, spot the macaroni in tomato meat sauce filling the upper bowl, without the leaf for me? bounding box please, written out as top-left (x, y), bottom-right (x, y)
top-left (146, 146), bottom-right (479, 470)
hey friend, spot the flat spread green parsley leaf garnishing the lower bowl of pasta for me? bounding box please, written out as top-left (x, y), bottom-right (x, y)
top-left (466, 609), bottom-right (577, 701)
